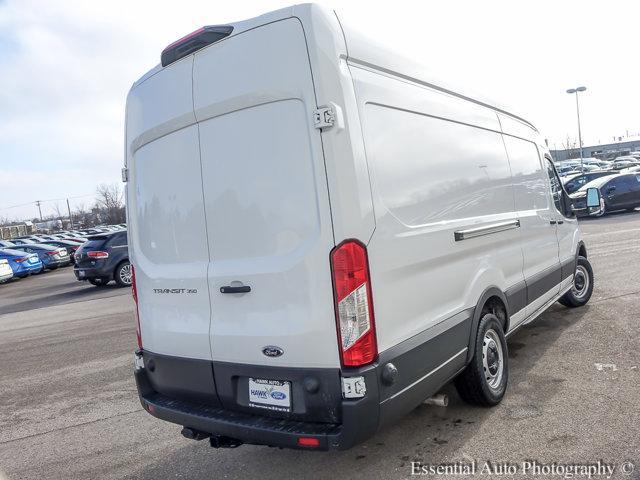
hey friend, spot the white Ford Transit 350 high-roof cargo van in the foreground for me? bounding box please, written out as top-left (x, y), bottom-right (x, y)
top-left (123, 5), bottom-right (599, 450)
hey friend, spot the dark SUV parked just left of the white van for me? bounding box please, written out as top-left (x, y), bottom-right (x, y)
top-left (73, 231), bottom-right (131, 287)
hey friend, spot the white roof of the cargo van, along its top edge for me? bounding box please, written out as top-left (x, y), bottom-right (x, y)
top-left (132, 3), bottom-right (538, 133)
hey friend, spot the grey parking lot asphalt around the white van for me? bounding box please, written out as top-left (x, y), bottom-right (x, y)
top-left (0, 212), bottom-right (640, 480)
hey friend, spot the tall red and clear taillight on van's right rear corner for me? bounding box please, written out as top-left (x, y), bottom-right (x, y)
top-left (331, 240), bottom-right (378, 367)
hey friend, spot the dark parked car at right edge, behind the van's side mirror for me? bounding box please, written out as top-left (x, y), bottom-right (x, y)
top-left (572, 173), bottom-right (640, 216)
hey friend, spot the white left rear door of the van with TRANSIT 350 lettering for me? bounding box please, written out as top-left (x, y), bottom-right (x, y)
top-left (127, 58), bottom-right (211, 360)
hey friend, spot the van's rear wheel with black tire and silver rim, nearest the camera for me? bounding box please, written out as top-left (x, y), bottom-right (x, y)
top-left (455, 313), bottom-right (509, 407)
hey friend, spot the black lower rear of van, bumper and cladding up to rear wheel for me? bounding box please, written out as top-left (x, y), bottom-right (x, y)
top-left (135, 309), bottom-right (473, 450)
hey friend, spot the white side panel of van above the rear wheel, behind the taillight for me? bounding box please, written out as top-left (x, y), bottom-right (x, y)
top-left (350, 65), bottom-right (523, 356)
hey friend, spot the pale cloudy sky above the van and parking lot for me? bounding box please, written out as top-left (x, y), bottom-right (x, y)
top-left (0, 0), bottom-right (640, 219)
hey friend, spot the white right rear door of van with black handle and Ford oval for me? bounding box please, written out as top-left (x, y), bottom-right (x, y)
top-left (193, 18), bottom-right (340, 368)
